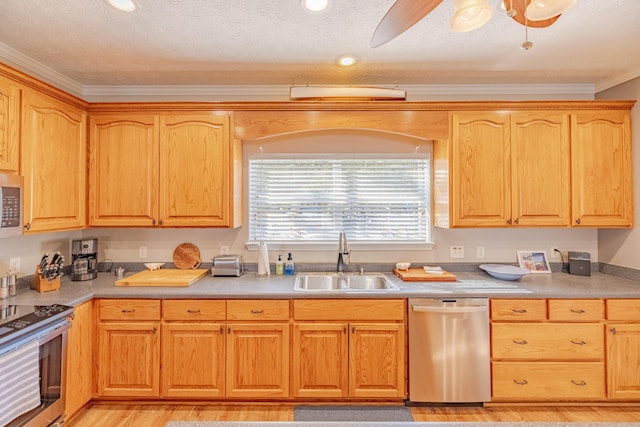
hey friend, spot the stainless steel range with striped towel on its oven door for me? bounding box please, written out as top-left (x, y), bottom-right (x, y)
top-left (0, 304), bottom-right (73, 427)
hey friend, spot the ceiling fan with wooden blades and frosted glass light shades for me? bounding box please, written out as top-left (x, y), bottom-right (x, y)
top-left (371, 0), bottom-right (577, 47)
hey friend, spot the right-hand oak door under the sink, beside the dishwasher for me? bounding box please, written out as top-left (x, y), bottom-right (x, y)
top-left (349, 323), bottom-right (406, 397)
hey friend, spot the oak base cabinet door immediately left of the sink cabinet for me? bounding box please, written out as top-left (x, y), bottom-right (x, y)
top-left (226, 323), bottom-right (289, 397)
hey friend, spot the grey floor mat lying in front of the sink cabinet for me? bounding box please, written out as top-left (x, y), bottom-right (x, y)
top-left (293, 406), bottom-right (413, 422)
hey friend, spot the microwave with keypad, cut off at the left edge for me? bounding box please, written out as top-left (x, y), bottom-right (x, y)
top-left (0, 174), bottom-right (24, 237)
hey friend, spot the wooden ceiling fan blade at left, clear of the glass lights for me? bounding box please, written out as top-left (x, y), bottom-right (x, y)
top-left (371, 0), bottom-right (442, 47)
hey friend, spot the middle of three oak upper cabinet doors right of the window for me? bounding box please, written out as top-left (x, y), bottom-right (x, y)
top-left (511, 112), bottom-right (570, 227)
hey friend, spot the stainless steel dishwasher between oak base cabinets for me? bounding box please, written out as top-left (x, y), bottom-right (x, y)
top-left (409, 298), bottom-right (491, 403)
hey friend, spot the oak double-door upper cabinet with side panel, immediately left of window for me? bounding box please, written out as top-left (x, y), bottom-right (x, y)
top-left (89, 113), bottom-right (242, 227)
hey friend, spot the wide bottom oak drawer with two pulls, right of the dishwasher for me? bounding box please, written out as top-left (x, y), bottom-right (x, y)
top-left (491, 362), bottom-right (605, 401)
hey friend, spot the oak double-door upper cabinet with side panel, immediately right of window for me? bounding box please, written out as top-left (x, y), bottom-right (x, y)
top-left (434, 112), bottom-right (569, 227)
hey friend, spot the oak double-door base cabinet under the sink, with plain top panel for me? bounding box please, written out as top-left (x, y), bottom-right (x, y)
top-left (292, 300), bottom-right (406, 398)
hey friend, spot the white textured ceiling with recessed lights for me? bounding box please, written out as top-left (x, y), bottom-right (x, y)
top-left (0, 0), bottom-right (640, 98)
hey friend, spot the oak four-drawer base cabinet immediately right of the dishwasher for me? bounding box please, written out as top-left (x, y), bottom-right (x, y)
top-left (491, 299), bottom-right (607, 402)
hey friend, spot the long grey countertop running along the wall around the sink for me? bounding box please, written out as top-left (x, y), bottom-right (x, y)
top-left (5, 272), bottom-right (640, 306)
